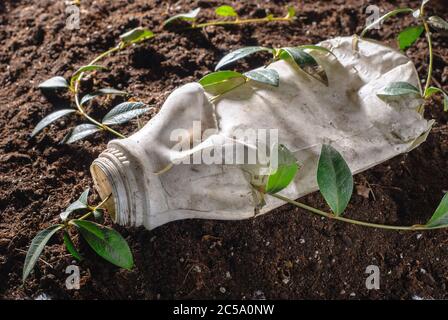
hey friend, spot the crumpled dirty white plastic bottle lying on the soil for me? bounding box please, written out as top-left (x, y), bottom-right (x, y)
top-left (94, 37), bottom-right (432, 229)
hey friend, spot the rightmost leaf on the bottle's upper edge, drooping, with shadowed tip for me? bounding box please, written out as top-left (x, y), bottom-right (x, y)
top-left (279, 47), bottom-right (328, 86)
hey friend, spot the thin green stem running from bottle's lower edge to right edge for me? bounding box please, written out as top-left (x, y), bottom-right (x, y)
top-left (269, 194), bottom-right (444, 231)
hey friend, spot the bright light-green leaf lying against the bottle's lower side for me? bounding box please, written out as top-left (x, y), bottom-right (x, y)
top-left (265, 145), bottom-right (299, 194)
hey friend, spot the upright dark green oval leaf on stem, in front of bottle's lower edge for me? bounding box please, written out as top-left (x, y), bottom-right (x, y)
top-left (317, 144), bottom-right (353, 216)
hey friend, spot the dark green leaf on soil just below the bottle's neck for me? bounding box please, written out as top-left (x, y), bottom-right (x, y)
top-left (71, 220), bottom-right (134, 270)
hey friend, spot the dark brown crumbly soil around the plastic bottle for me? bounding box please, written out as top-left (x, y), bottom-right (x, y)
top-left (0, 0), bottom-right (448, 299)
